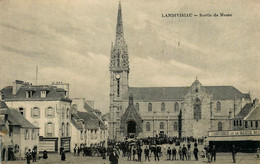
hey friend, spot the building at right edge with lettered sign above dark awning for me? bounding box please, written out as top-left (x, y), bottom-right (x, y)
top-left (208, 99), bottom-right (260, 152)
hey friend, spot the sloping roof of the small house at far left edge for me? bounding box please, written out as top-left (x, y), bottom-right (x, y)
top-left (8, 109), bottom-right (39, 129)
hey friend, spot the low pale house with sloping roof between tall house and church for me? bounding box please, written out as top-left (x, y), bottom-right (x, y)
top-left (71, 98), bottom-right (108, 150)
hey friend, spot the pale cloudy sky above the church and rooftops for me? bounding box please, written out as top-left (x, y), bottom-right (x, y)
top-left (0, 0), bottom-right (260, 112)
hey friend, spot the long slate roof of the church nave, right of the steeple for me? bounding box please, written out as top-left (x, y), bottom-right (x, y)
top-left (127, 86), bottom-right (250, 101)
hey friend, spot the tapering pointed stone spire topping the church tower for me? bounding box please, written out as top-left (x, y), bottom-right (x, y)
top-left (115, 2), bottom-right (124, 45)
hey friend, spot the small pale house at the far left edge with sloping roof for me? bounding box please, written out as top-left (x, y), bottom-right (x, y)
top-left (0, 101), bottom-right (39, 161)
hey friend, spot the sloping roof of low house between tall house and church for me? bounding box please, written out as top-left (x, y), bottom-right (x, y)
top-left (77, 111), bottom-right (106, 130)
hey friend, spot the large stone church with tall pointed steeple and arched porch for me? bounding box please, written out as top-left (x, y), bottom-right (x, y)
top-left (109, 3), bottom-right (251, 140)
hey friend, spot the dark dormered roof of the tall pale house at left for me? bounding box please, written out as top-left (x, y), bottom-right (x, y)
top-left (1, 85), bottom-right (71, 102)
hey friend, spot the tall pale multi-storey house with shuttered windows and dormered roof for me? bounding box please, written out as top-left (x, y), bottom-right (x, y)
top-left (1, 80), bottom-right (72, 152)
